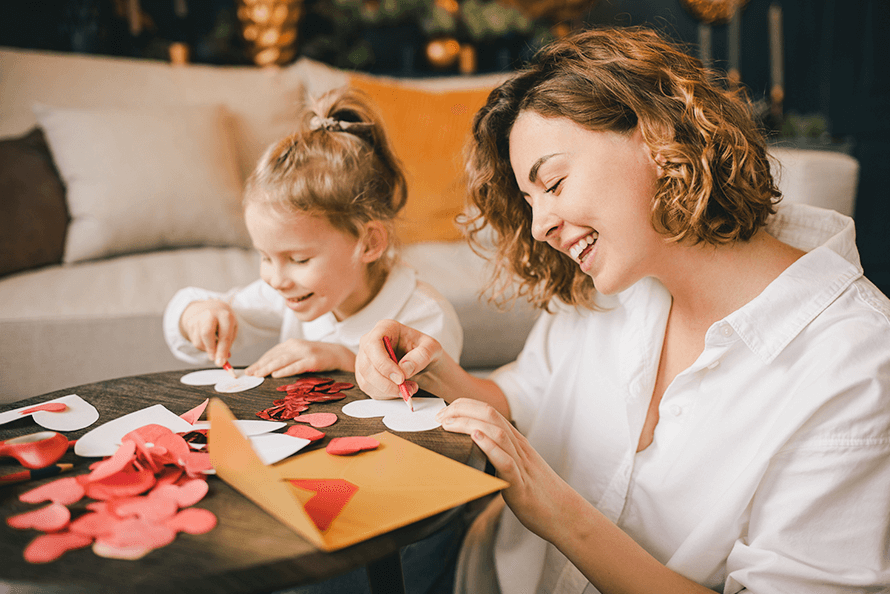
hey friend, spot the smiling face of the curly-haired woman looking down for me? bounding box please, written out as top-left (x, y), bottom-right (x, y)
top-left (510, 111), bottom-right (665, 295)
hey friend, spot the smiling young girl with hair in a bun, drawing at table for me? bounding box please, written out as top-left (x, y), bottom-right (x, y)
top-left (164, 88), bottom-right (463, 377)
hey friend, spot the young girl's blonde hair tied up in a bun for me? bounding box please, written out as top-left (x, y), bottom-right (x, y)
top-left (244, 87), bottom-right (408, 270)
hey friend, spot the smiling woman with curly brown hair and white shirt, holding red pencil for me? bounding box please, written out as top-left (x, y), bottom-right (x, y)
top-left (356, 29), bottom-right (890, 594)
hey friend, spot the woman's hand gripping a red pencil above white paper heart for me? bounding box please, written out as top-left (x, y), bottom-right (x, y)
top-left (355, 320), bottom-right (444, 400)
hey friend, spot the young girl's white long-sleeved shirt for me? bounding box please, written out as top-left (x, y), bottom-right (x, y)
top-left (164, 262), bottom-right (463, 364)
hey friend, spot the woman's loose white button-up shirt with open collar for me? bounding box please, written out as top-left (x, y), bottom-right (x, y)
top-left (486, 205), bottom-right (890, 594)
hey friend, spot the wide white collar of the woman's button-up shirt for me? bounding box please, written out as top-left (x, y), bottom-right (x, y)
top-left (709, 204), bottom-right (862, 363)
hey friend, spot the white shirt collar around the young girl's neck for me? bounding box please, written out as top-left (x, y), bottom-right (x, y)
top-left (303, 264), bottom-right (417, 344)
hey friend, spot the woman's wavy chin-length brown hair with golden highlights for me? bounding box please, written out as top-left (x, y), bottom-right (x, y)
top-left (463, 27), bottom-right (781, 310)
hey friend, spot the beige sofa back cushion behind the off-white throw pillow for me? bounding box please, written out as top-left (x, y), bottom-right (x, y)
top-left (0, 48), bottom-right (306, 177)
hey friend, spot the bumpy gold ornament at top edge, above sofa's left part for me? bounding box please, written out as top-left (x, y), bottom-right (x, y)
top-left (238, 0), bottom-right (303, 66)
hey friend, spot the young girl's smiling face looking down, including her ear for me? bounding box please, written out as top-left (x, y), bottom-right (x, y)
top-left (244, 204), bottom-right (385, 322)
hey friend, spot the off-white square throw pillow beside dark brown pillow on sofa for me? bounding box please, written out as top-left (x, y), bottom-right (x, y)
top-left (34, 104), bottom-right (250, 263)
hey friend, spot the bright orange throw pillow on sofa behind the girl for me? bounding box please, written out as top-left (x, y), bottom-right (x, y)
top-left (350, 74), bottom-right (491, 243)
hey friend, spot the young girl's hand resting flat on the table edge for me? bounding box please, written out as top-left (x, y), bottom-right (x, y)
top-left (244, 338), bottom-right (355, 377)
